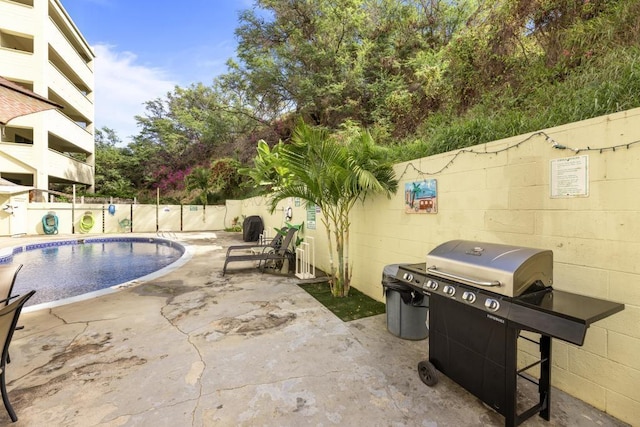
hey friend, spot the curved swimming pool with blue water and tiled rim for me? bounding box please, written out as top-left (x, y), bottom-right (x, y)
top-left (0, 237), bottom-right (186, 308)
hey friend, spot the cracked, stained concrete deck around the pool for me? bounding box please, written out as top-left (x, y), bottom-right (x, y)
top-left (0, 232), bottom-right (626, 427)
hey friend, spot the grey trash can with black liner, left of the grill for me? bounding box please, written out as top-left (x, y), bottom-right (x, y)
top-left (382, 264), bottom-right (429, 340)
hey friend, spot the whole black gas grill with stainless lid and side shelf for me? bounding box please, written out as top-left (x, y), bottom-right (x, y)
top-left (396, 240), bottom-right (624, 426)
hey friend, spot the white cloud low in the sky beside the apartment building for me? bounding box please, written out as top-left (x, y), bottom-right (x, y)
top-left (93, 44), bottom-right (177, 144)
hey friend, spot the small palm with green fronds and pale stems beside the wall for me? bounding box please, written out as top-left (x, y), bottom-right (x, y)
top-left (245, 122), bottom-right (398, 297)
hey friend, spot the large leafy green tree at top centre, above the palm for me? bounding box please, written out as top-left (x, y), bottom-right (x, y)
top-left (232, 0), bottom-right (477, 134)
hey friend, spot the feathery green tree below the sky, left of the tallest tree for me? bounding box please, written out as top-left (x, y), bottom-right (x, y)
top-left (131, 79), bottom-right (257, 196)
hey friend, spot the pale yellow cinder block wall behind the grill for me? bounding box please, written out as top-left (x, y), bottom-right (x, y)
top-left (344, 109), bottom-right (640, 425)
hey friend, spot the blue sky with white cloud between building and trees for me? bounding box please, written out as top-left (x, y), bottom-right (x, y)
top-left (61, 0), bottom-right (253, 144)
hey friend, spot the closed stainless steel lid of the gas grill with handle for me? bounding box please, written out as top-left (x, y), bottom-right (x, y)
top-left (426, 240), bottom-right (553, 297)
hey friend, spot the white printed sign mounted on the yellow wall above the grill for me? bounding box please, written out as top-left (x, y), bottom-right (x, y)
top-left (549, 156), bottom-right (589, 199)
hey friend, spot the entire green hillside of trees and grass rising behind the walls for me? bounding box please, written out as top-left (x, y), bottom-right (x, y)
top-left (89, 0), bottom-right (640, 203)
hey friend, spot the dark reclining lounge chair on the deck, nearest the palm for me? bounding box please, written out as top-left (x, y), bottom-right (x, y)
top-left (222, 227), bottom-right (298, 276)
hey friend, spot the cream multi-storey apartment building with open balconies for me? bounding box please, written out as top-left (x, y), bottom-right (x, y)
top-left (0, 0), bottom-right (95, 201)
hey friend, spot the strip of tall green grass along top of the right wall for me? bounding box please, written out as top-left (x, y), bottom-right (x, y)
top-left (391, 46), bottom-right (640, 161)
